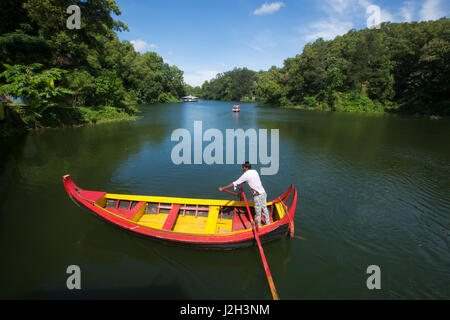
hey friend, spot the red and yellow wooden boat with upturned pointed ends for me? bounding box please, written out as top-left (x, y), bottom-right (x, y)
top-left (63, 175), bottom-right (297, 249)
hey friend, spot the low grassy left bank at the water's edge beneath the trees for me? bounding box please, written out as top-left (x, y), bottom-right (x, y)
top-left (0, 103), bottom-right (139, 139)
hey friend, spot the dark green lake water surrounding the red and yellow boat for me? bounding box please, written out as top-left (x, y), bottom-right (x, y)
top-left (0, 101), bottom-right (450, 299)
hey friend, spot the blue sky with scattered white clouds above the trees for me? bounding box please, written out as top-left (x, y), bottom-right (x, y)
top-left (116, 0), bottom-right (450, 85)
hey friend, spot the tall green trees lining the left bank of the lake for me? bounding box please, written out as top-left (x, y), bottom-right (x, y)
top-left (0, 0), bottom-right (184, 129)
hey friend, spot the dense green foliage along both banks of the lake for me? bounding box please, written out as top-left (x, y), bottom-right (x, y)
top-left (0, 0), bottom-right (450, 131)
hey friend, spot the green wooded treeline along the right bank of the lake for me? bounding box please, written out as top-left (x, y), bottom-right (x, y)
top-left (197, 18), bottom-right (450, 116)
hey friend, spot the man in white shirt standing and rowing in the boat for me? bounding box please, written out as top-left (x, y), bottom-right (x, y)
top-left (219, 161), bottom-right (270, 227)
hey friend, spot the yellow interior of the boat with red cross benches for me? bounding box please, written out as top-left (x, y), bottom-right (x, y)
top-left (95, 194), bottom-right (288, 235)
